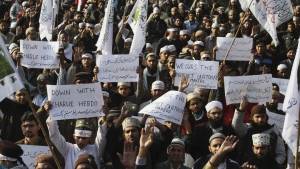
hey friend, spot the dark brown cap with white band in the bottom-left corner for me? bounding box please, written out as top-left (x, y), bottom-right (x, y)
top-left (0, 140), bottom-right (23, 162)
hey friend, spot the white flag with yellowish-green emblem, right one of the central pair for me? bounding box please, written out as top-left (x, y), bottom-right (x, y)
top-left (127, 0), bottom-right (148, 55)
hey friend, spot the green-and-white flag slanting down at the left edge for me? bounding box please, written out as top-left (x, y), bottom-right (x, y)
top-left (0, 36), bottom-right (24, 101)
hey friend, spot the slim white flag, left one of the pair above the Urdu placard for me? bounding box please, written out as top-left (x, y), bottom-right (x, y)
top-left (96, 0), bottom-right (114, 55)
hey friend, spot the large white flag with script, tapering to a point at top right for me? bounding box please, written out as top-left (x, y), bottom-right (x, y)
top-left (239, 0), bottom-right (293, 46)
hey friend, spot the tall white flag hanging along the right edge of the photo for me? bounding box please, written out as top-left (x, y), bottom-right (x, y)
top-left (282, 39), bottom-right (300, 156)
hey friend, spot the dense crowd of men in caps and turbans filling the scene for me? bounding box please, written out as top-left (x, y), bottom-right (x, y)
top-left (0, 0), bottom-right (300, 169)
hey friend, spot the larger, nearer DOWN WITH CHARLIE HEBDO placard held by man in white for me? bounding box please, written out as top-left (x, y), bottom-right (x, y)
top-left (47, 83), bottom-right (103, 120)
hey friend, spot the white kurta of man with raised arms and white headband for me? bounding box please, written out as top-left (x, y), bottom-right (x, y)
top-left (47, 118), bottom-right (107, 169)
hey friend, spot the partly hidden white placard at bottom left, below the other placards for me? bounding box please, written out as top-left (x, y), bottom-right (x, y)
top-left (20, 145), bottom-right (51, 169)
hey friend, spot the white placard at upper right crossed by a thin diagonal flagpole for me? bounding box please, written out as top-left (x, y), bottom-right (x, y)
top-left (216, 37), bottom-right (253, 61)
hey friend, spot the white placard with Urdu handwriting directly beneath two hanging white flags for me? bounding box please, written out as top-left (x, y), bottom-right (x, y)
top-left (96, 55), bottom-right (139, 82)
